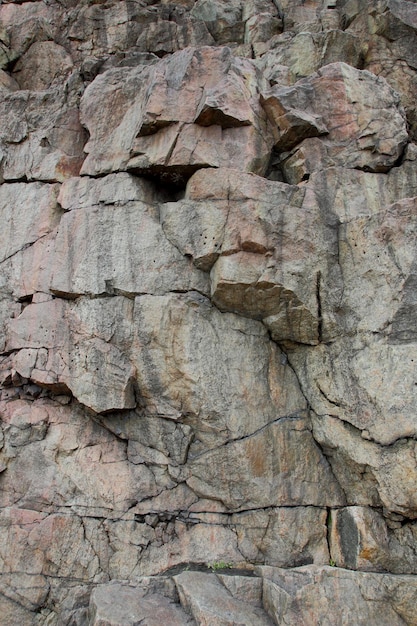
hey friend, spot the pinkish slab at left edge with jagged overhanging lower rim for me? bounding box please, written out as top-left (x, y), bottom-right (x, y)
top-left (6, 298), bottom-right (136, 412)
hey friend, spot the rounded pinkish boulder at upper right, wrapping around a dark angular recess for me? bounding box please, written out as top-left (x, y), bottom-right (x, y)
top-left (265, 63), bottom-right (408, 183)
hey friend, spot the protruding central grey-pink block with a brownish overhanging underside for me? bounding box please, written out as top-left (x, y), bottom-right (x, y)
top-left (161, 169), bottom-right (334, 344)
